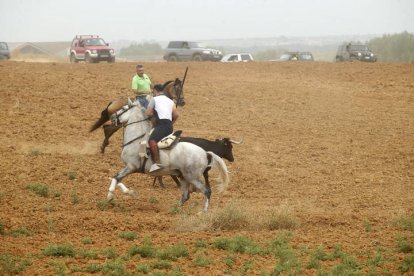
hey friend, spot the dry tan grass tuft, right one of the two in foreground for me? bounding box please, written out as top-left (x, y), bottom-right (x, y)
top-left (263, 204), bottom-right (299, 230)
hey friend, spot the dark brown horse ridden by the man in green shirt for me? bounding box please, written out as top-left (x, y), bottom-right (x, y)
top-left (89, 78), bottom-right (185, 153)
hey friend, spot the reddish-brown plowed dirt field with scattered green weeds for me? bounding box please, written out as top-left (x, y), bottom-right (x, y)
top-left (0, 61), bottom-right (414, 275)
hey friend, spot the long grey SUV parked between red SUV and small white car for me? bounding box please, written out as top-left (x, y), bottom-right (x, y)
top-left (164, 41), bottom-right (223, 61)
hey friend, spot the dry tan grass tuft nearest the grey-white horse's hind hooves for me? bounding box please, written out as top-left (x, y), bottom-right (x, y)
top-left (210, 202), bottom-right (249, 230)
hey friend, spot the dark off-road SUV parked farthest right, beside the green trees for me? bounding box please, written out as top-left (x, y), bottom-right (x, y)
top-left (335, 43), bottom-right (377, 62)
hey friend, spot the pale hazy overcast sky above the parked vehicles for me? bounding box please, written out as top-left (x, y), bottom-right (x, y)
top-left (0, 0), bottom-right (414, 42)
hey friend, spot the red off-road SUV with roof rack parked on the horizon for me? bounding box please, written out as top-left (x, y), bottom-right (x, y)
top-left (69, 35), bottom-right (115, 63)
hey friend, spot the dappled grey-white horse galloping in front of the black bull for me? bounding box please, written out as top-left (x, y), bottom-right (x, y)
top-left (108, 100), bottom-right (229, 212)
